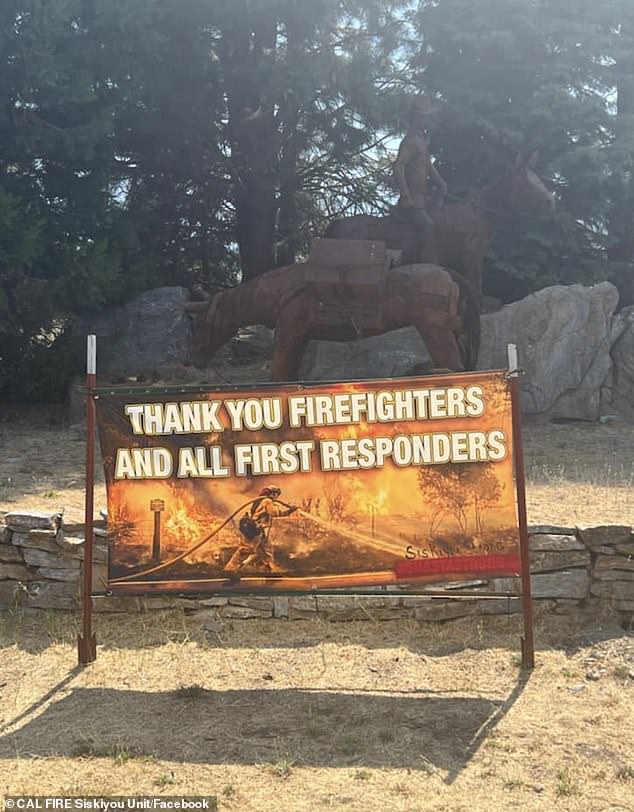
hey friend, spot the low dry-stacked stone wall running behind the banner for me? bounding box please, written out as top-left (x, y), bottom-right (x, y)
top-left (0, 512), bottom-right (634, 624)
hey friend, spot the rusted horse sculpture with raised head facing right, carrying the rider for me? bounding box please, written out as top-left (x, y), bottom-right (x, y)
top-left (326, 153), bottom-right (554, 297)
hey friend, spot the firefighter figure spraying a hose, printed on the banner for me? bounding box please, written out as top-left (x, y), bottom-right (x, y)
top-left (225, 485), bottom-right (297, 573)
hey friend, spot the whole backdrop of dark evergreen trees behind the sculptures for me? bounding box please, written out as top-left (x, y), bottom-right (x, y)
top-left (0, 0), bottom-right (634, 397)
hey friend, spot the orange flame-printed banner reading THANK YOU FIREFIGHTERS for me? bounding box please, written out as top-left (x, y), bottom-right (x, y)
top-left (97, 372), bottom-right (520, 594)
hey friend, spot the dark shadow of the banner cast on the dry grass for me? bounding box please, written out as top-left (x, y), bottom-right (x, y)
top-left (0, 678), bottom-right (527, 783)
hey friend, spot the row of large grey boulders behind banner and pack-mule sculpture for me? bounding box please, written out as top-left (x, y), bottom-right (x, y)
top-left (77, 282), bottom-right (634, 420)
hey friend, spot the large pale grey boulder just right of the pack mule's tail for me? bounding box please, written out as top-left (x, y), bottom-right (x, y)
top-left (478, 282), bottom-right (618, 420)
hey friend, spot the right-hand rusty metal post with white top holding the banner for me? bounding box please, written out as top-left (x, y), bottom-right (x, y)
top-left (507, 344), bottom-right (535, 671)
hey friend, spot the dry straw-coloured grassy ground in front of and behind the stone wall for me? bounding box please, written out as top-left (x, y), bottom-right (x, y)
top-left (0, 409), bottom-right (634, 812)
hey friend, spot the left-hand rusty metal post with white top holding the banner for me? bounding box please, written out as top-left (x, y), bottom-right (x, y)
top-left (77, 335), bottom-right (97, 665)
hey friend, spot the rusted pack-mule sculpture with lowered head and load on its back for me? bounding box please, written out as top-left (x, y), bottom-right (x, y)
top-left (187, 240), bottom-right (479, 380)
